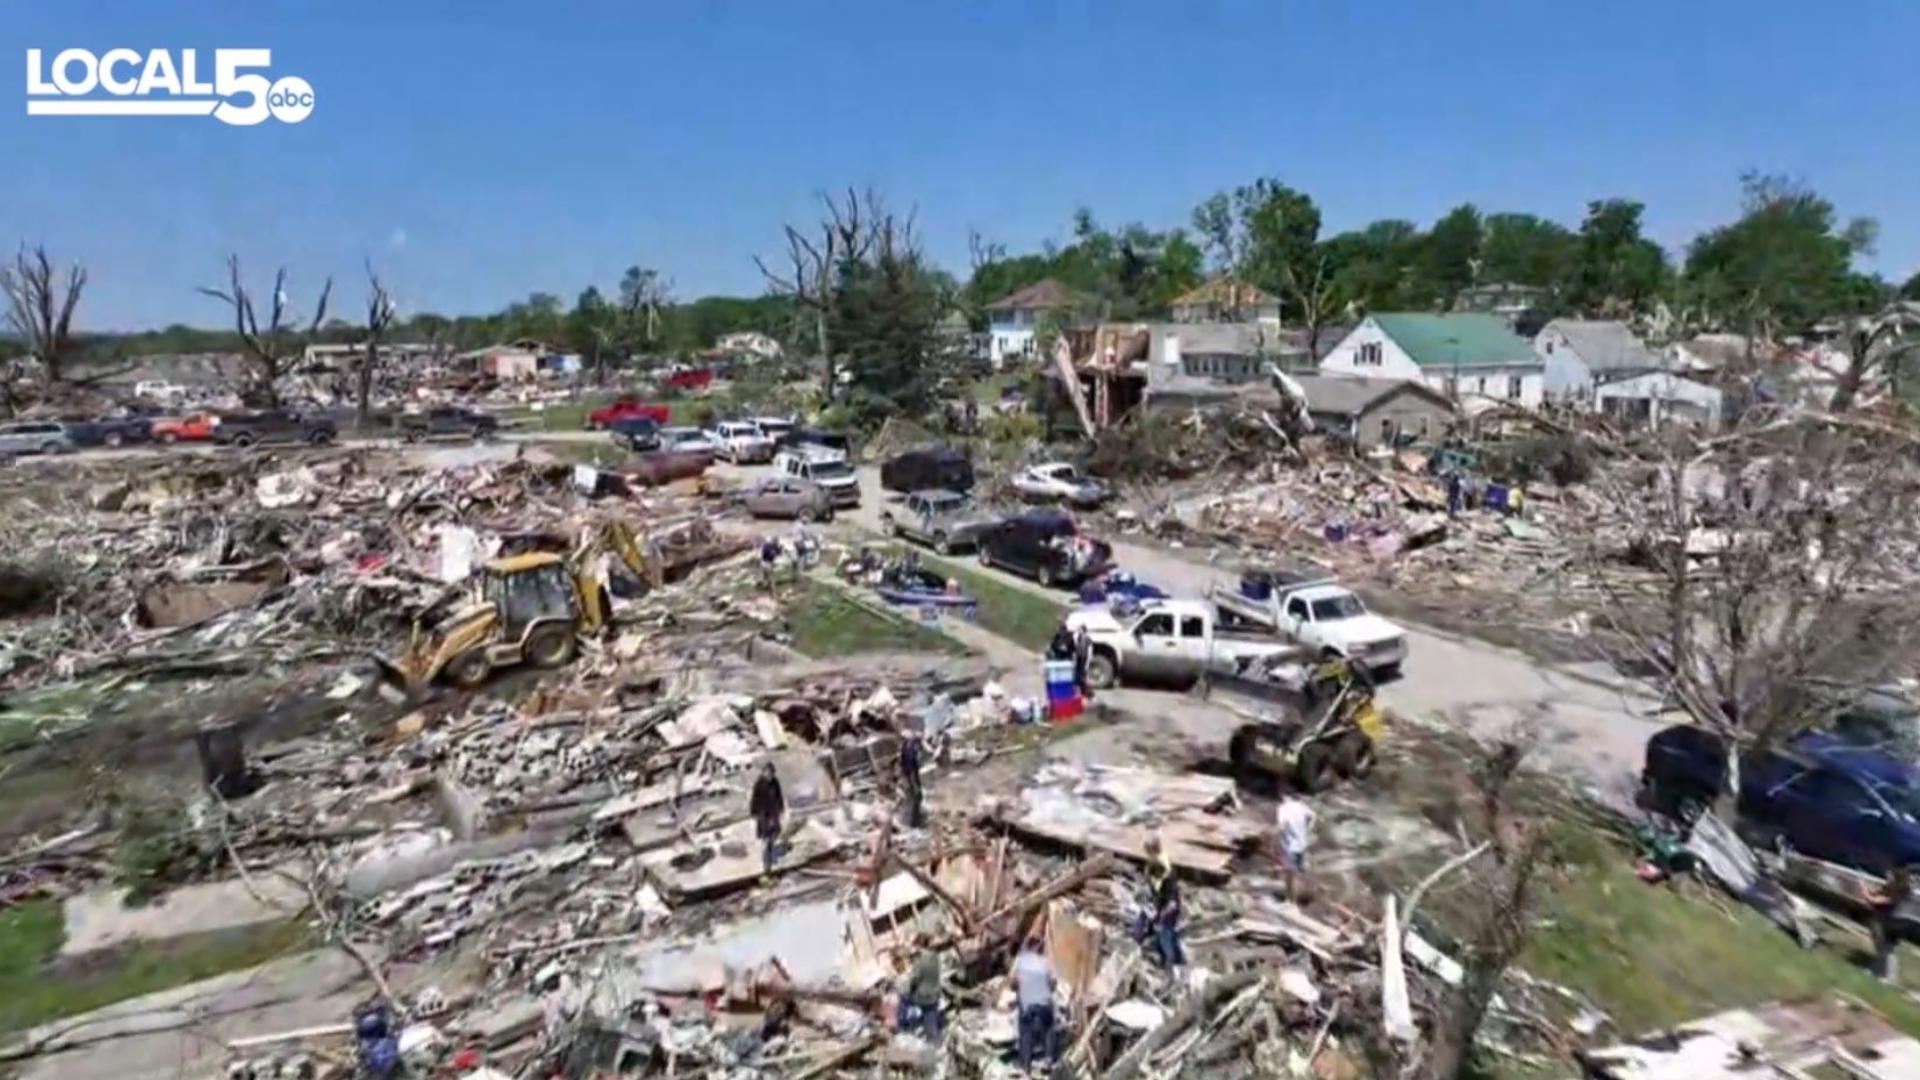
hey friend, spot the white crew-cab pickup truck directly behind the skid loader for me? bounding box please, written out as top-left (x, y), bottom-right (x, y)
top-left (1068, 600), bottom-right (1304, 690)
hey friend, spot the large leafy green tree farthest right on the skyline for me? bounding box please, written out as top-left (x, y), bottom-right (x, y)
top-left (1686, 173), bottom-right (1878, 338)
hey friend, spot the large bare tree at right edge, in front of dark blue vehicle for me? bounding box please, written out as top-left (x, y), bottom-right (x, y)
top-left (1590, 407), bottom-right (1920, 819)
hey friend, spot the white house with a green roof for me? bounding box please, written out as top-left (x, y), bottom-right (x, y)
top-left (1319, 311), bottom-right (1546, 411)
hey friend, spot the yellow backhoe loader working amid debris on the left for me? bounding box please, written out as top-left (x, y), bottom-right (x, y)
top-left (376, 521), bottom-right (662, 700)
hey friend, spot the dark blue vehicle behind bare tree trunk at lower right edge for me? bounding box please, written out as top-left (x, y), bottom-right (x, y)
top-left (1640, 724), bottom-right (1920, 874)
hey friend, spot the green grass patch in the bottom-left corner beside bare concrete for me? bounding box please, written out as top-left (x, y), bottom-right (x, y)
top-left (0, 899), bottom-right (311, 1032)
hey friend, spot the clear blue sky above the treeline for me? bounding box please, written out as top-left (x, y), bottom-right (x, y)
top-left (0, 0), bottom-right (1920, 329)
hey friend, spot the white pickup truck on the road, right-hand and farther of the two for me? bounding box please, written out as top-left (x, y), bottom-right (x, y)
top-left (1206, 571), bottom-right (1407, 676)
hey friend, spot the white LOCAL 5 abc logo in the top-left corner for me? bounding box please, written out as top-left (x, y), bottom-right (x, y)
top-left (27, 48), bottom-right (313, 127)
